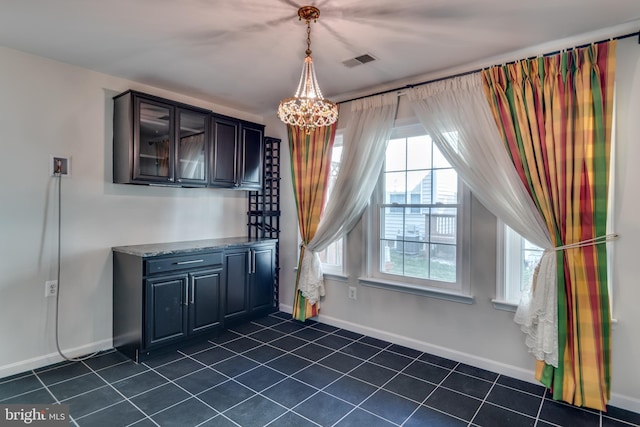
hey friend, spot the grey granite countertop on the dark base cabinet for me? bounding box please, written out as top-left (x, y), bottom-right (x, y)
top-left (111, 237), bottom-right (276, 257)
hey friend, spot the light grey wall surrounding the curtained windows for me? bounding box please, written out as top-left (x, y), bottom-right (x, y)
top-left (267, 38), bottom-right (640, 412)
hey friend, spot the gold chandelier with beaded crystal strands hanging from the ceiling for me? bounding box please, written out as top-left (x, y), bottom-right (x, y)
top-left (278, 6), bottom-right (338, 133)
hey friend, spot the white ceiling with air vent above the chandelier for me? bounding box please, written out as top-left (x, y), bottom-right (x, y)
top-left (0, 0), bottom-right (640, 115)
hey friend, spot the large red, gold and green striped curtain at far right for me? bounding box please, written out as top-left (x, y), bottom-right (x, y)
top-left (483, 41), bottom-right (616, 410)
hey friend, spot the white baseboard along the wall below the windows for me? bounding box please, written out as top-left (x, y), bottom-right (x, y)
top-left (280, 304), bottom-right (640, 413)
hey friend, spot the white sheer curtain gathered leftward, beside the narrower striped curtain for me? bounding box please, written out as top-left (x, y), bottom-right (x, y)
top-left (298, 93), bottom-right (398, 303)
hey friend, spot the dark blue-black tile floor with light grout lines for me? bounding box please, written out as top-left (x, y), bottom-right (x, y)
top-left (0, 313), bottom-right (640, 427)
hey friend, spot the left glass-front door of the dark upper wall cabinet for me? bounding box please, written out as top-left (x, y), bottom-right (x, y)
top-left (134, 98), bottom-right (174, 182)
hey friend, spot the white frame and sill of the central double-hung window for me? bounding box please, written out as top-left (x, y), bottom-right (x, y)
top-left (360, 125), bottom-right (474, 304)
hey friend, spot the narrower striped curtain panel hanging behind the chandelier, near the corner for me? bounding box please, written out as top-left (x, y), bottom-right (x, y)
top-left (287, 123), bottom-right (336, 321)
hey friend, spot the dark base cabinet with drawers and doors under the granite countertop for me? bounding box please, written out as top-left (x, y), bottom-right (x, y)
top-left (113, 241), bottom-right (277, 361)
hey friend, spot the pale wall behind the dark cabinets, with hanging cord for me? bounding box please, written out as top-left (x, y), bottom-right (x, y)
top-left (0, 48), bottom-right (262, 377)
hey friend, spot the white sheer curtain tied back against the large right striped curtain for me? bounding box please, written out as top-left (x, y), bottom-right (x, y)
top-left (407, 73), bottom-right (558, 366)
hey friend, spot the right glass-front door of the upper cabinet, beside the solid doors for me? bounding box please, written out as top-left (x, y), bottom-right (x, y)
top-left (176, 109), bottom-right (209, 185)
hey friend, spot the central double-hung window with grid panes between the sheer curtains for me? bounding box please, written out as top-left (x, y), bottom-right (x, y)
top-left (365, 126), bottom-right (469, 295)
